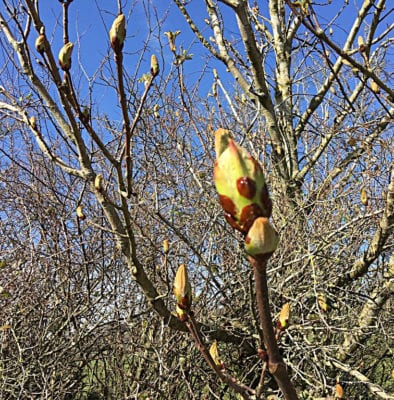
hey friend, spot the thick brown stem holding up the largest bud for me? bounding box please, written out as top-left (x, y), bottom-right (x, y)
top-left (249, 256), bottom-right (298, 400)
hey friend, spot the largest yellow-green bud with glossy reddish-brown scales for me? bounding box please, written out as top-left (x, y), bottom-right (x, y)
top-left (214, 129), bottom-right (272, 234)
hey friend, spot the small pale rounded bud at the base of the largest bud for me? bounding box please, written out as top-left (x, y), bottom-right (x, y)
top-left (245, 217), bottom-right (279, 257)
